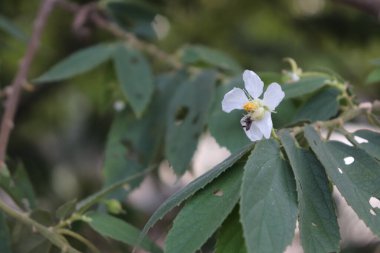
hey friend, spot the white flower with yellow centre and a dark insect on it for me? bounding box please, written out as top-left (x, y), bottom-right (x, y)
top-left (222, 70), bottom-right (285, 141)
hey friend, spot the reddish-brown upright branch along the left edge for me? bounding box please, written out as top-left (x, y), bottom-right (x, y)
top-left (0, 0), bottom-right (55, 166)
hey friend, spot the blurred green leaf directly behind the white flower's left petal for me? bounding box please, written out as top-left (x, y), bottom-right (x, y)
top-left (208, 75), bottom-right (250, 153)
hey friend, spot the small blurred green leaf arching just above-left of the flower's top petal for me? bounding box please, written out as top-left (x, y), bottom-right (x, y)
top-left (181, 45), bottom-right (242, 73)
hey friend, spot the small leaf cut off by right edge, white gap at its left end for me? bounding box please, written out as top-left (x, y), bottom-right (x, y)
top-left (353, 130), bottom-right (380, 160)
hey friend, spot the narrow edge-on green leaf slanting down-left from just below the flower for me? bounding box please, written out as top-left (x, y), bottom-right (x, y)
top-left (142, 144), bottom-right (252, 237)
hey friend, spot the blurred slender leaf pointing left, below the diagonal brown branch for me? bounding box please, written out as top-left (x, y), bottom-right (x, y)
top-left (33, 44), bottom-right (115, 83)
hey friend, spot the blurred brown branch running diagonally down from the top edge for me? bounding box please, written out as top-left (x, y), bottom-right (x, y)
top-left (57, 0), bottom-right (183, 69)
